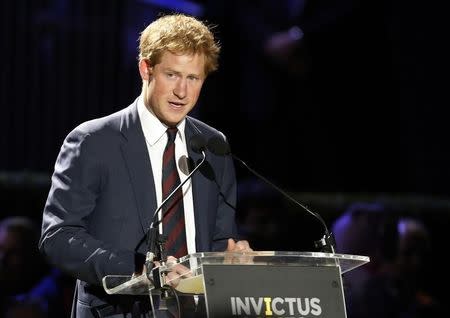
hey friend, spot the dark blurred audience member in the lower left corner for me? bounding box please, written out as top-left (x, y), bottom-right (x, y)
top-left (0, 216), bottom-right (68, 318)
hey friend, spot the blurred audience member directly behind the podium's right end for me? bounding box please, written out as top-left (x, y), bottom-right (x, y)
top-left (332, 202), bottom-right (397, 318)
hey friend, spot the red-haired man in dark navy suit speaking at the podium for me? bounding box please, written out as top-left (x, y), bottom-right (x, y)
top-left (39, 14), bottom-right (251, 317)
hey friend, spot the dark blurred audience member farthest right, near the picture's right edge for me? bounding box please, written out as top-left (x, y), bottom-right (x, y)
top-left (362, 217), bottom-right (444, 318)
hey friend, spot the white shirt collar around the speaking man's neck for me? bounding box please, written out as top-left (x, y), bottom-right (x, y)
top-left (137, 96), bottom-right (186, 146)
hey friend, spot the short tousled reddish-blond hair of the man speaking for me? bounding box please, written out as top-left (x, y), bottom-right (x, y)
top-left (139, 13), bottom-right (220, 75)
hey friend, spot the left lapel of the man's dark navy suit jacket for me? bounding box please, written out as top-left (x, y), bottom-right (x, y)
top-left (120, 101), bottom-right (156, 232)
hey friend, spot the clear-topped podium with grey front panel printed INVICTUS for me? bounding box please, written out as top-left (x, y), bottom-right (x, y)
top-left (103, 251), bottom-right (370, 318)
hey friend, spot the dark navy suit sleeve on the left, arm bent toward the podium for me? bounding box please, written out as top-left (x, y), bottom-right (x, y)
top-left (39, 128), bottom-right (144, 285)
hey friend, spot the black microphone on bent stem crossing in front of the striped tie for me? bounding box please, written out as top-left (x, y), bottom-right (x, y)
top-left (145, 134), bottom-right (207, 286)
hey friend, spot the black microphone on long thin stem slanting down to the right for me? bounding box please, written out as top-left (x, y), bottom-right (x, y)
top-left (207, 136), bottom-right (336, 253)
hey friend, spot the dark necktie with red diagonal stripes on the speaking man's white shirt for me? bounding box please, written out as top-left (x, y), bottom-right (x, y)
top-left (162, 128), bottom-right (187, 258)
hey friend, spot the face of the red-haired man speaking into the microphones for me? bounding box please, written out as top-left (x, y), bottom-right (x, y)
top-left (140, 52), bottom-right (205, 126)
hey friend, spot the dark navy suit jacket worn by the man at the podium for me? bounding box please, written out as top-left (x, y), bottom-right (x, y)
top-left (39, 100), bottom-right (236, 317)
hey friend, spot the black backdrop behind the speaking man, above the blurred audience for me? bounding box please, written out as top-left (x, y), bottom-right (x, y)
top-left (0, 0), bottom-right (450, 308)
